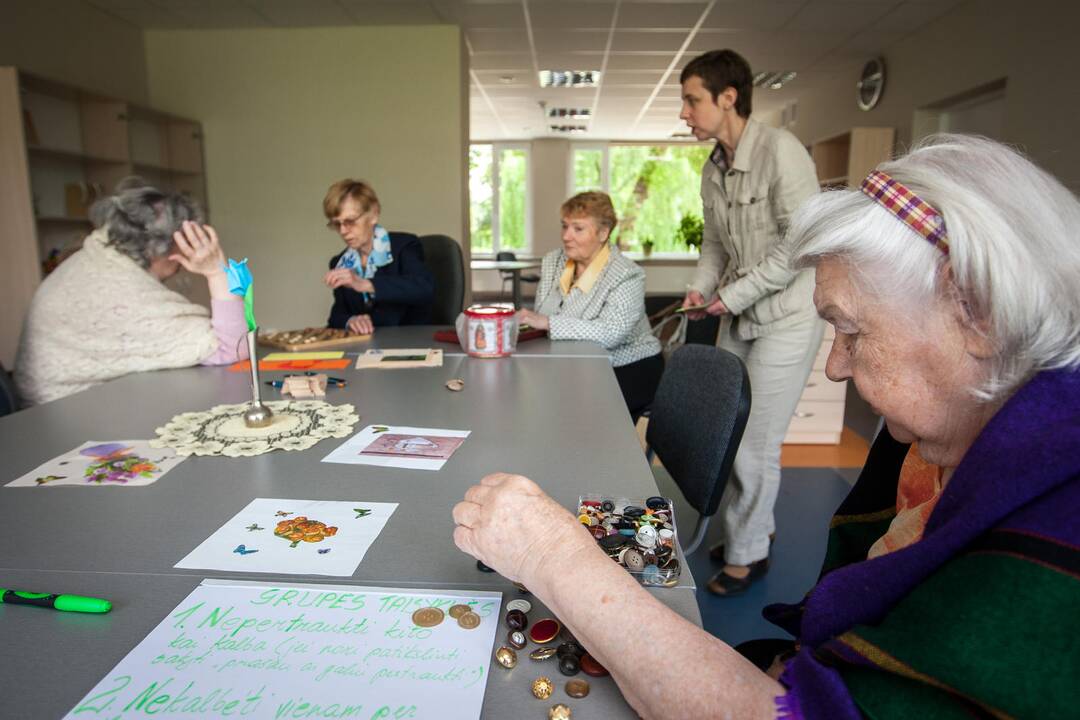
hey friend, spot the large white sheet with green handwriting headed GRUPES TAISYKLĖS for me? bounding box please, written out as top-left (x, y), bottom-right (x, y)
top-left (65, 580), bottom-right (502, 720)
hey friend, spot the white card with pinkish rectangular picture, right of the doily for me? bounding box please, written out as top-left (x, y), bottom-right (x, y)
top-left (323, 425), bottom-right (469, 470)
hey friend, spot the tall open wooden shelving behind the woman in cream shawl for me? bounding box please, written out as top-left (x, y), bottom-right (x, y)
top-left (0, 67), bottom-right (208, 369)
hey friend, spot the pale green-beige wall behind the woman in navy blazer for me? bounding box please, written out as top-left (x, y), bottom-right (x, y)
top-left (146, 26), bottom-right (468, 328)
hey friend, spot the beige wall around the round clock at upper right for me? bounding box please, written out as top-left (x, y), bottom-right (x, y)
top-left (792, 0), bottom-right (1080, 191)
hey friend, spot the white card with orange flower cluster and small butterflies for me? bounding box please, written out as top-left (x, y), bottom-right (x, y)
top-left (174, 498), bottom-right (397, 576)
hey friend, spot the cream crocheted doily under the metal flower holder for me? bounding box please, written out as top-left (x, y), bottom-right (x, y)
top-left (150, 400), bottom-right (360, 458)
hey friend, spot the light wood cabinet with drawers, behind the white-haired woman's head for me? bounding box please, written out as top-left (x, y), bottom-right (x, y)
top-left (784, 127), bottom-right (896, 445)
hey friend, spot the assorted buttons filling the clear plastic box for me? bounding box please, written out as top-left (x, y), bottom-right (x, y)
top-left (578, 495), bottom-right (679, 587)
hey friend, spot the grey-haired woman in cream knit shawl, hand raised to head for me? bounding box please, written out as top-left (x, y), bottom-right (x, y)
top-left (15, 180), bottom-right (247, 405)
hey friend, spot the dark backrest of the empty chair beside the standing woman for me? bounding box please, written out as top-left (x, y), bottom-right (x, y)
top-left (645, 344), bottom-right (750, 555)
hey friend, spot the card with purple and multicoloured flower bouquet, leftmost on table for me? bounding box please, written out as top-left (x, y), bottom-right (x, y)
top-left (8, 440), bottom-right (185, 488)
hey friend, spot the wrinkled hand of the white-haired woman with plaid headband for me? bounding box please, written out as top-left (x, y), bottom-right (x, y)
top-left (454, 473), bottom-right (598, 585)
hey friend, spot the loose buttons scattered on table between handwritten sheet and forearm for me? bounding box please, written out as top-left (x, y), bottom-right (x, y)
top-left (490, 599), bottom-right (608, 720)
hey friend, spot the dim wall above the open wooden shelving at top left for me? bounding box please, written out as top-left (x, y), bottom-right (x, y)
top-left (0, 0), bottom-right (147, 104)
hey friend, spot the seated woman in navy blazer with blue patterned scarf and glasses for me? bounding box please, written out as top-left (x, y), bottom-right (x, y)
top-left (323, 179), bottom-right (435, 335)
